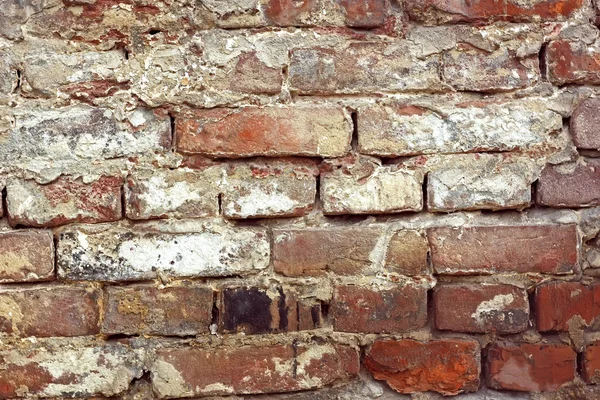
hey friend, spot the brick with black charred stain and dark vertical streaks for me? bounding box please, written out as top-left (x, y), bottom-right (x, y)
top-left (219, 287), bottom-right (322, 334)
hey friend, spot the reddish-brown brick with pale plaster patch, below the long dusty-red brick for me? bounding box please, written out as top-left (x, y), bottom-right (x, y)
top-left (433, 284), bottom-right (529, 333)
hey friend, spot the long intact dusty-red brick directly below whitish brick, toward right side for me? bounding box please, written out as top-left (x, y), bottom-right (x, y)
top-left (427, 225), bottom-right (579, 275)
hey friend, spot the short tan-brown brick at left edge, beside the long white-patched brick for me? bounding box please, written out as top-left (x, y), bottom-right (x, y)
top-left (0, 230), bottom-right (54, 282)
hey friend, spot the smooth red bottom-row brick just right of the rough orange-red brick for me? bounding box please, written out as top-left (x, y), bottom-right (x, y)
top-left (488, 343), bottom-right (577, 392)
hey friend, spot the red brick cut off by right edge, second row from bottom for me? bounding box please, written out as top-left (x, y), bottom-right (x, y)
top-left (535, 282), bottom-right (600, 332)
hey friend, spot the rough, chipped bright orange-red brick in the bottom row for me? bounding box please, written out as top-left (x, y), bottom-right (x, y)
top-left (365, 340), bottom-right (481, 395)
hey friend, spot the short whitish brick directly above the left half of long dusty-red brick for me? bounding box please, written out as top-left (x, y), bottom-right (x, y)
top-left (427, 154), bottom-right (538, 211)
